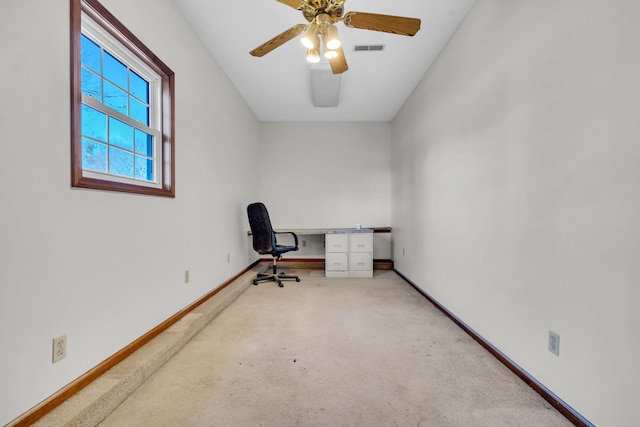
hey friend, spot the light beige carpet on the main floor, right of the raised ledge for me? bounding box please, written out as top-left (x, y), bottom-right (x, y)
top-left (100, 270), bottom-right (572, 427)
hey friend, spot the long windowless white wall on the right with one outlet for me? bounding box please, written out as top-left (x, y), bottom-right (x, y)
top-left (392, 0), bottom-right (640, 426)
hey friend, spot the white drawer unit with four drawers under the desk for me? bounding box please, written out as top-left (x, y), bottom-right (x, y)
top-left (325, 230), bottom-right (373, 277)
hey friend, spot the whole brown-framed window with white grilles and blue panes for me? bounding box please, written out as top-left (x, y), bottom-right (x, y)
top-left (71, 0), bottom-right (175, 197)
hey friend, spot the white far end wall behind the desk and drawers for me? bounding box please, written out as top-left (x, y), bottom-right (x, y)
top-left (259, 122), bottom-right (391, 259)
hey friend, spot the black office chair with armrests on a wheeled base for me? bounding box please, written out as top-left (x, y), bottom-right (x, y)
top-left (247, 202), bottom-right (300, 287)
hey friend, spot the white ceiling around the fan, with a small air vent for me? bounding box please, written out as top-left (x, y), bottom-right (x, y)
top-left (174, 0), bottom-right (475, 121)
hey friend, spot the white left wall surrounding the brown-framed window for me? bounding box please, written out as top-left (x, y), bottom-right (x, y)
top-left (0, 0), bottom-right (259, 425)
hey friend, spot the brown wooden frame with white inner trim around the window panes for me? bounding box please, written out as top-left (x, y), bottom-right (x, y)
top-left (70, 0), bottom-right (175, 197)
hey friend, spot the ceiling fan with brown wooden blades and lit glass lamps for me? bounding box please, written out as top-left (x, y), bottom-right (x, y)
top-left (249, 0), bottom-right (420, 74)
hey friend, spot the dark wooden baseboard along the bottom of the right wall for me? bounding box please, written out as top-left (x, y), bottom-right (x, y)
top-left (394, 269), bottom-right (594, 427)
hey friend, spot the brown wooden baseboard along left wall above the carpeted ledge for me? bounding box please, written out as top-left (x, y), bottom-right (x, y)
top-left (7, 261), bottom-right (260, 427)
